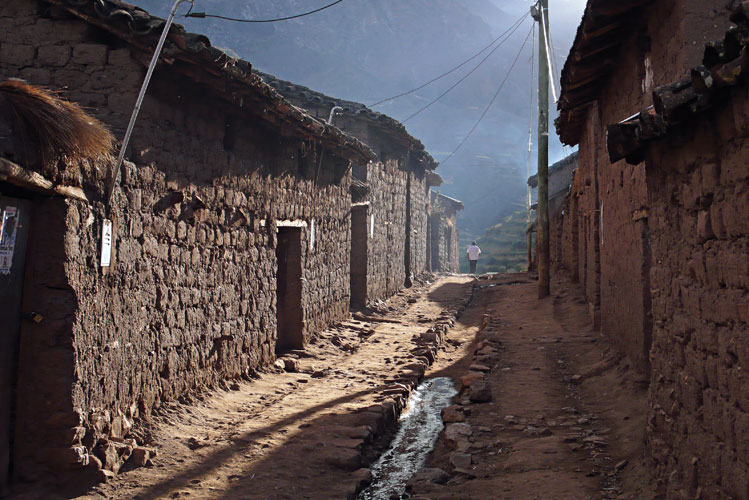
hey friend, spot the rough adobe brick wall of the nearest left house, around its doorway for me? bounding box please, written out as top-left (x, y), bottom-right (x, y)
top-left (0, 0), bottom-right (350, 480)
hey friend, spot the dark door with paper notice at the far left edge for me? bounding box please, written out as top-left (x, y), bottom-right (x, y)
top-left (0, 195), bottom-right (31, 496)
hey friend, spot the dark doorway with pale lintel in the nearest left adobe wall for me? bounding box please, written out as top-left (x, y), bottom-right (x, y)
top-left (276, 227), bottom-right (304, 354)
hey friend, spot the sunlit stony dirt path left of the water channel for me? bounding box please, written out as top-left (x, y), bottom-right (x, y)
top-left (51, 277), bottom-right (471, 500)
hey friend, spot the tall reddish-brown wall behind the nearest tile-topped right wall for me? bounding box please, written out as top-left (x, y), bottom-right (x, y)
top-left (564, 0), bottom-right (730, 372)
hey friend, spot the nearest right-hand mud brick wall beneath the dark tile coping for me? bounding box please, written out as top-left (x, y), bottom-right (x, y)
top-left (647, 88), bottom-right (749, 499)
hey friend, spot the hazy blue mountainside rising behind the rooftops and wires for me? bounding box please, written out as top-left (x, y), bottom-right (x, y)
top-left (134, 0), bottom-right (580, 237)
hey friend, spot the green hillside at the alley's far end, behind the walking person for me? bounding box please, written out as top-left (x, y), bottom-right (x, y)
top-left (460, 210), bottom-right (527, 273)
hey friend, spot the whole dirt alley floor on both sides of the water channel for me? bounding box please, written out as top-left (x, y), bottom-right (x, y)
top-left (19, 274), bottom-right (654, 500)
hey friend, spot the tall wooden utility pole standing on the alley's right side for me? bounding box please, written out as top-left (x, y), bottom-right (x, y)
top-left (531, 0), bottom-right (550, 299)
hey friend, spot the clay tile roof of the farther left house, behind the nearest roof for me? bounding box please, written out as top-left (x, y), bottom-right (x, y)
top-left (253, 69), bottom-right (438, 170)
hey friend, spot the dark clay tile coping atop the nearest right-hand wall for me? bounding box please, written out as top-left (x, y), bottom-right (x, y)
top-left (606, 2), bottom-right (749, 164)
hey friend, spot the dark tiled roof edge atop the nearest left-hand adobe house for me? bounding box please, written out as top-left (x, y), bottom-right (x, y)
top-left (44, 0), bottom-right (376, 163)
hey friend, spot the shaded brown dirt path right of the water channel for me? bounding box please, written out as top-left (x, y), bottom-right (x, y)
top-left (411, 275), bottom-right (652, 500)
